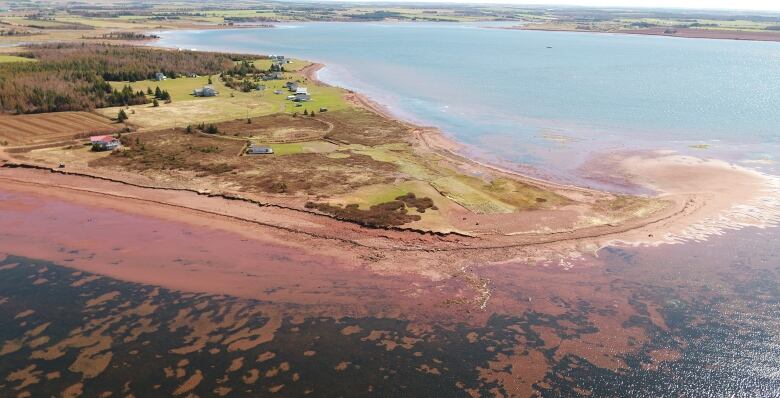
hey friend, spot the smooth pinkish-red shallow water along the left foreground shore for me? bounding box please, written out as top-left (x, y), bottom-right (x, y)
top-left (0, 189), bottom-right (464, 316)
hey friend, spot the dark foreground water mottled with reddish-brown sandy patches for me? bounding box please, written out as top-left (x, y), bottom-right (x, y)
top-left (0, 194), bottom-right (780, 397)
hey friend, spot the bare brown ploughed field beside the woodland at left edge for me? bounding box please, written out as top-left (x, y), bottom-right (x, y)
top-left (0, 112), bottom-right (119, 145)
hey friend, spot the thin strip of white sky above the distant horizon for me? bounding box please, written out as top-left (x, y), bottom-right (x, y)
top-left (332, 0), bottom-right (780, 11)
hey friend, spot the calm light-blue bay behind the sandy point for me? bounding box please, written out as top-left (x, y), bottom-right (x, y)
top-left (156, 23), bottom-right (780, 187)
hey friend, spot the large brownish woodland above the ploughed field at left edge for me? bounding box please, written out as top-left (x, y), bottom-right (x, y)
top-left (0, 43), bottom-right (245, 113)
